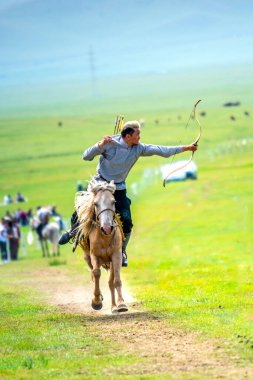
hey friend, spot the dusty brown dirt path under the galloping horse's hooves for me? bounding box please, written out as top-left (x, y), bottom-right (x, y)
top-left (29, 267), bottom-right (253, 380)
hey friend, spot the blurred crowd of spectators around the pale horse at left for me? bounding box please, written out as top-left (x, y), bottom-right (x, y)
top-left (0, 206), bottom-right (65, 264)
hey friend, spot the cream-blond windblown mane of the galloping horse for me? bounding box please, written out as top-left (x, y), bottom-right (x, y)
top-left (75, 179), bottom-right (116, 239)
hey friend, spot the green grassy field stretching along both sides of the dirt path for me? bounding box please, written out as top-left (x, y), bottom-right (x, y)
top-left (0, 70), bottom-right (253, 378)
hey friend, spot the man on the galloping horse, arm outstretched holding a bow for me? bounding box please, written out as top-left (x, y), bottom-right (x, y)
top-left (59, 121), bottom-right (197, 267)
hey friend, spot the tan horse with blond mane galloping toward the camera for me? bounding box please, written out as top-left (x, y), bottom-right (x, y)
top-left (74, 180), bottom-right (128, 313)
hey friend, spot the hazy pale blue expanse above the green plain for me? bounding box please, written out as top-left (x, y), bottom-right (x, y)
top-left (0, 0), bottom-right (253, 85)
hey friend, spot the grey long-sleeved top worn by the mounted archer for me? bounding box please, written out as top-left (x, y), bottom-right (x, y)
top-left (83, 135), bottom-right (183, 190)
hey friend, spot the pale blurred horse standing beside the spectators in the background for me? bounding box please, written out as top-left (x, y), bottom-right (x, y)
top-left (30, 217), bottom-right (60, 257)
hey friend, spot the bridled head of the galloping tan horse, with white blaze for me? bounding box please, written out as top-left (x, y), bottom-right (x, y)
top-left (94, 185), bottom-right (115, 235)
